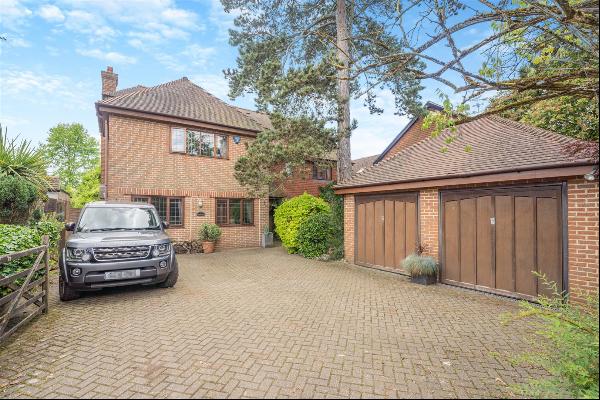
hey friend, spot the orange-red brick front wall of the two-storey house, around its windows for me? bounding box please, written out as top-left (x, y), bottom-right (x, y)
top-left (102, 115), bottom-right (268, 248)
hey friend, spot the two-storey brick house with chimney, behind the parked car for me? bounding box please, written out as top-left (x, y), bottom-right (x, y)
top-left (96, 67), bottom-right (333, 248)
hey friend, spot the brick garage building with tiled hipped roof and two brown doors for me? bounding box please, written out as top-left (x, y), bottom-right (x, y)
top-left (336, 116), bottom-right (599, 298)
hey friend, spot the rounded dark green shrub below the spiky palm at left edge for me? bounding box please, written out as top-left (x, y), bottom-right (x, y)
top-left (0, 175), bottom-right (39, 224)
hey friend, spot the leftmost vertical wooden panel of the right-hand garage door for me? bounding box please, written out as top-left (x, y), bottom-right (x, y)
top-left (442, 201), bottom-right (460, 281)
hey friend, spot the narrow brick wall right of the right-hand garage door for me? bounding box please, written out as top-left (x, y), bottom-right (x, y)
top-left (567, 179), bottom-right (600, 297)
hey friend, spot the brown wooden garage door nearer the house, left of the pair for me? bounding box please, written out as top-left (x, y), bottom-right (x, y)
top-left (355, 193), bottom-right (418, 270)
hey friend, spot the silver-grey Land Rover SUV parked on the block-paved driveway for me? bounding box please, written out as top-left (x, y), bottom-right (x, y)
top-left (59, 201), bottom-right (179, 301)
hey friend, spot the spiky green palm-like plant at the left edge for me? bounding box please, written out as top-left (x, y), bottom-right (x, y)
top-left (0, 125), bottom-right (49, 192)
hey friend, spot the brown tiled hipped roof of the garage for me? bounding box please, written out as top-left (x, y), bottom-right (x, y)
top-left (337, 116), bottom-right (593, 188)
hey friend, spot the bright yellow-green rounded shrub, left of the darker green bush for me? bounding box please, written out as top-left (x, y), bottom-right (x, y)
top-left (275, 193), bottom-right (331, 254)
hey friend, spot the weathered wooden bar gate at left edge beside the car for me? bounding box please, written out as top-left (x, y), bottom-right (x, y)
top-left (0, 236), bottom-right (49, 343)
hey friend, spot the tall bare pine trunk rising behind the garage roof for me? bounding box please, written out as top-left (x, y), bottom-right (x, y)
top-left (336, 0), bottom-right (352, 182)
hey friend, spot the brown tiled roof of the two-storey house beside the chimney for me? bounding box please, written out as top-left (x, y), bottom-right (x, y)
top-left (97, 77), bottom-right (265, 132)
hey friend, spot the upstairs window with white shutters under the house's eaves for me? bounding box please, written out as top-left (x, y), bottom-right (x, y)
top-left (171, 128), bottom-right (228, 158)
